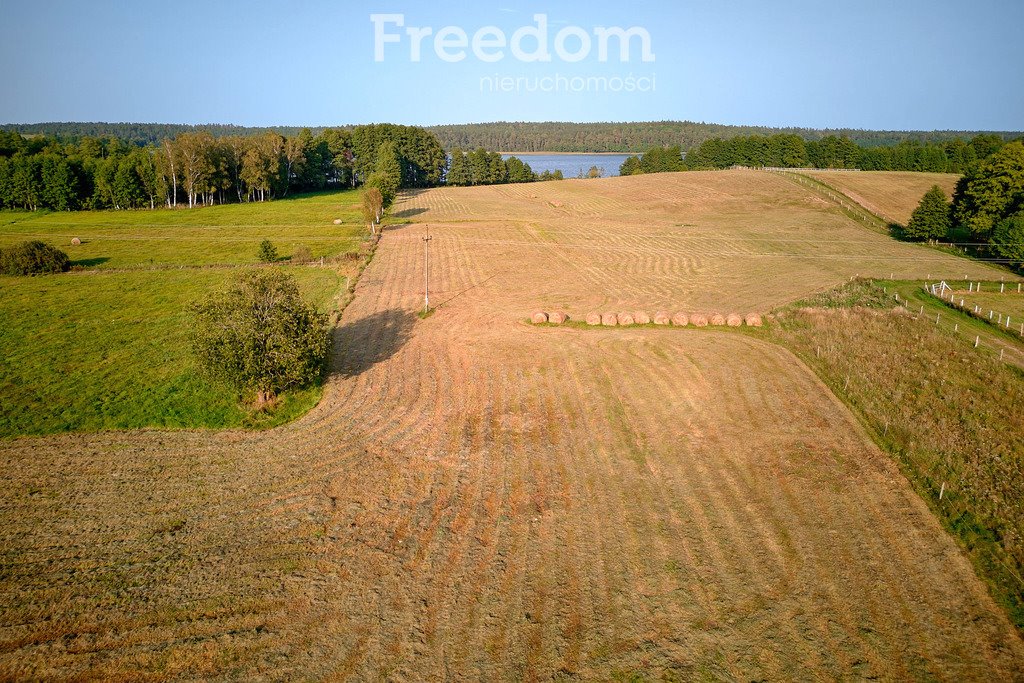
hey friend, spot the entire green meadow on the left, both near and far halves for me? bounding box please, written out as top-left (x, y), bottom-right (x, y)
top-left (0, 193), bottom-right (364, 437)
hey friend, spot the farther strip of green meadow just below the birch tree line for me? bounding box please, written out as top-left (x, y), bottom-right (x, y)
top-left (0, 190), bottom-right (364, 268)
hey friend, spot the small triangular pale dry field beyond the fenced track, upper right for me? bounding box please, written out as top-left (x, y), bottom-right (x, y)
top-left (802, 171), bottom-right (959, 225)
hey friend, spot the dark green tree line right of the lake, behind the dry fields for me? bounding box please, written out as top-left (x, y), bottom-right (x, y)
top-left (620, 133), bottom-right (1004, 175)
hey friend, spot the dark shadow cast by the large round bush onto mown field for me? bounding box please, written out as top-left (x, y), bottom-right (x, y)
top-left (331, 308), bottom-right (416, 377)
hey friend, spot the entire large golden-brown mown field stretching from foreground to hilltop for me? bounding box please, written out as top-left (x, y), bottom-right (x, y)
top-left (0, 171), bottom-right (1024, 681)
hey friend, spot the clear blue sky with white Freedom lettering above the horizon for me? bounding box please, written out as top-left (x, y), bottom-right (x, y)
top-left (0, 0), bottom-right (1024, 130)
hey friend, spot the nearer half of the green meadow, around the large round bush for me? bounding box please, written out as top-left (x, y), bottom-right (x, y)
top-left (0, 266), bottom-right (344, 436)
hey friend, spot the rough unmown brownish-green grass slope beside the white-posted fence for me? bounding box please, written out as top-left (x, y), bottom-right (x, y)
top-left (771, 284), bottom-right (1024, 628)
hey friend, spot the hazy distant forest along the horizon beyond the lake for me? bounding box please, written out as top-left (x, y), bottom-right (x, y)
top-left (0, 121), bottom-right (1022, 153)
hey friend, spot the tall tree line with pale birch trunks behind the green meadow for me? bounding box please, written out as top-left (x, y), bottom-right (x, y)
top-left (0, 124), bottom-right (447, 211)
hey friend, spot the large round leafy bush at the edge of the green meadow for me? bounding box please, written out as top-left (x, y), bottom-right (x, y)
top-left (188, 270), bottom-right (329, 408)
